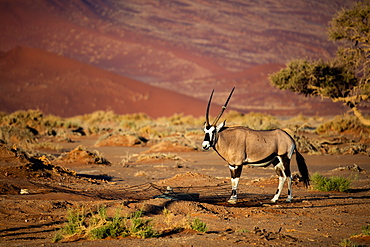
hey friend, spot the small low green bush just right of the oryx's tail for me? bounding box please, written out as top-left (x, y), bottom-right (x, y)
top-left (311, 173), bottom-right (352, 192)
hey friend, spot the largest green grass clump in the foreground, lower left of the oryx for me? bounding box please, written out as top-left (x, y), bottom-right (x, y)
top-left (52, 206), bottom-right (158, 242)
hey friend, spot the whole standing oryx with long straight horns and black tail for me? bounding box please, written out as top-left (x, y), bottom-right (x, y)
top-left (202, 87), bottom-right (309, 204)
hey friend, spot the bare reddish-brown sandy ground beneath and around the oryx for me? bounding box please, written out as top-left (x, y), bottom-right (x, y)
top-left (0, 137), bottom-right (370, 246)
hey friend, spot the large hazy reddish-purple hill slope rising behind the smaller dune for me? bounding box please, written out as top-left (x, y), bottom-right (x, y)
top-left (0, 0), bottom-right (355, 115)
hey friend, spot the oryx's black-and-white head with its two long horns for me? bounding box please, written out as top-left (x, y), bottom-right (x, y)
top-left (202, 87), bottom-right (235, 150)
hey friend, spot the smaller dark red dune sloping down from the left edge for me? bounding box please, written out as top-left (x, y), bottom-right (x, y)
top-left (0, 47), bottom-right (217, 117)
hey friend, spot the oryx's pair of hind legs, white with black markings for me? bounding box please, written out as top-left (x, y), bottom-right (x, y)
top-left (271, 156), bottom-right (292, 202)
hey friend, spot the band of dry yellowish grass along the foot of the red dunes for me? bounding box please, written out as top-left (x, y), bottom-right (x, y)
top-left (0, 110), bottom-right (370, 157)
